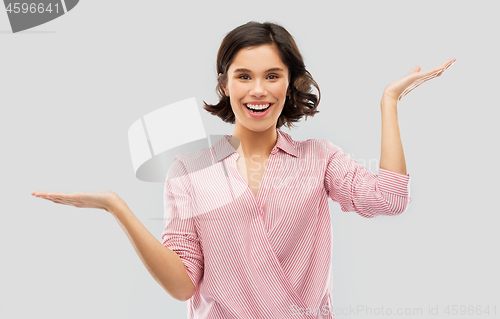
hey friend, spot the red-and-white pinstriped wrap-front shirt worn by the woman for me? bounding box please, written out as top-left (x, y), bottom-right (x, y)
top-left (162, 129), bottom-right (411, 319)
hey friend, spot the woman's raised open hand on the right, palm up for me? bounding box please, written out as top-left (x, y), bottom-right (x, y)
top-left (384, 59), bottom-right (456, 101)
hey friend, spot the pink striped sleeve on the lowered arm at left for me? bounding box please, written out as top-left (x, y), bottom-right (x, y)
top-left (162, 158), bottom-right (204, 287)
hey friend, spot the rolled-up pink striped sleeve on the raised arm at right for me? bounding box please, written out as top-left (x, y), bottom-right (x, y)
top-left (323, 140), bottom-right (412, 218)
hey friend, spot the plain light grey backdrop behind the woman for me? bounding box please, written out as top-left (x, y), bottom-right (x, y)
top-left (0, 0), bottom-right (500, 318)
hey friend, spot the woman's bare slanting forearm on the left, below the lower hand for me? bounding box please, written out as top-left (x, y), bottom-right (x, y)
top-left (109, 198), bottom-right (195, 301)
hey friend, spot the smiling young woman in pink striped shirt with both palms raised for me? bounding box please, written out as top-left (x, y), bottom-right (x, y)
top-left (32, 22), bottom-right (455, 318)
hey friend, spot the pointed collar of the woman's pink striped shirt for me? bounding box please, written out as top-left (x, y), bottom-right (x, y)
top-left (212, 128), bottom-right (299, 162)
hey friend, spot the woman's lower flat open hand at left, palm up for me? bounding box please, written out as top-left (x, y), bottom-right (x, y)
top-left (31, 191), bottom-right (120, 213)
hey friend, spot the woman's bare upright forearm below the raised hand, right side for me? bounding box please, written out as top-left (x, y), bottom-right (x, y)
top-left (379, 95), bottom-right (407, 175)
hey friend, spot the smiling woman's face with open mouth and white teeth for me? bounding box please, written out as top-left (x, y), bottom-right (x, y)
top-left (224, 45), bottom-right (289, 132)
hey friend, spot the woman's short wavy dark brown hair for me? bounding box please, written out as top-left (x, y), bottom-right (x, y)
top-left (203, 21), bottom-right (321, 128)
